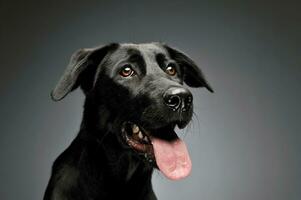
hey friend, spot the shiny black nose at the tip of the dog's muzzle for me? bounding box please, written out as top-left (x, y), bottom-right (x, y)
top-left (163, 87), bottom-right (192, 112)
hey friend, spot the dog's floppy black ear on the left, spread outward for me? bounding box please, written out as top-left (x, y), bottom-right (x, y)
top-left (51, 43), bottom-right (118, 101)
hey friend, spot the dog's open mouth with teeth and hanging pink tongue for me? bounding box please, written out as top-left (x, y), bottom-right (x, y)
top-left (122, 122), bottom-right (191, 180)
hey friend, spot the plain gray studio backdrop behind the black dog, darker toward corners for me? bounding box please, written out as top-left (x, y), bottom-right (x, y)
top-left (0, 0), bottom-right (301, 200)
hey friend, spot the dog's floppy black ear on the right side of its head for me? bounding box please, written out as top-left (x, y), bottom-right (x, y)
top-left (164, 45), bottom-right (213, 92)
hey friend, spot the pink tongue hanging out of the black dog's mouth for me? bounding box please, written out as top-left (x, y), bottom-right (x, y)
top-left (152, 138), bottom-right (191, 180)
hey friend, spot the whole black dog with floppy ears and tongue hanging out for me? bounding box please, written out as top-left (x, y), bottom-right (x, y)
top-left (44, 43), bottom-right (213, 200)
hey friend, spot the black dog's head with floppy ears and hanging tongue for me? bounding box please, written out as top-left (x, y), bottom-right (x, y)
top-left (51, 43), bottom-right (213, 179)
